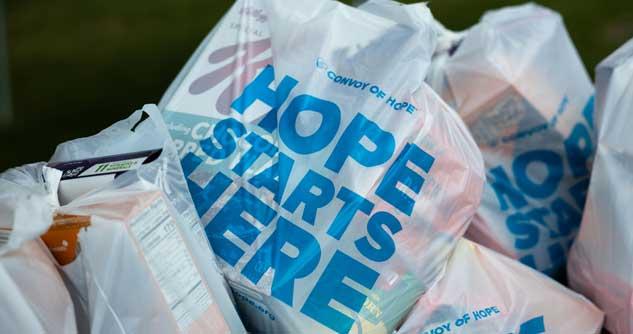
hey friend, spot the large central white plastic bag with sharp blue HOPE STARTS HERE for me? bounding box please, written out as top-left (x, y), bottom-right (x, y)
top-left (161, 0), bottom-right (483, 333)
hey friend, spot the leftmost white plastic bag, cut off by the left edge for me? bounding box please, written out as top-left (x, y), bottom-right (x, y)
top-left (0, 163), bottom-right (77, 334)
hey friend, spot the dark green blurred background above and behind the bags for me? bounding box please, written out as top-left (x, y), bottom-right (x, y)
top-left (0, 0), bottom-right (633, 170)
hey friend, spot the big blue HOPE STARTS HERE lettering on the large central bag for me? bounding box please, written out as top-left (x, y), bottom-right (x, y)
top-left (182, 66), bottom-right (435, 332)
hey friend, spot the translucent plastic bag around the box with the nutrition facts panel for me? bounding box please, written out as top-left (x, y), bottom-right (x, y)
top-left (51, 105), bottom-right (245, 334)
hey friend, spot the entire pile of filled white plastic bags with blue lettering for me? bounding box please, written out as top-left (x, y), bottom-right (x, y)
top-left (0, 0), bottom-right (633, 334)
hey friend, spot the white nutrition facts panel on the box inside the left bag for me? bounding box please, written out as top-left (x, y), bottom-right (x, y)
top-left (130, 196), bottom-right (212, 330)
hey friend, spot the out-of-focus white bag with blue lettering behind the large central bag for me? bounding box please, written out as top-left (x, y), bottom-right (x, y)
top-left (428, 4), bottom-right (595, 278)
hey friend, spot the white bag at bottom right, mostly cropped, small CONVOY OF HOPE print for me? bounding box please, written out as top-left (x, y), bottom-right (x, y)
top-left (398, 239), bottom-right (603, 334)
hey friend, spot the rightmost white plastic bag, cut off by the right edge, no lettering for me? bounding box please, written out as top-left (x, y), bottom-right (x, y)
top-left (567, 36), bottom-right (633, 334)
